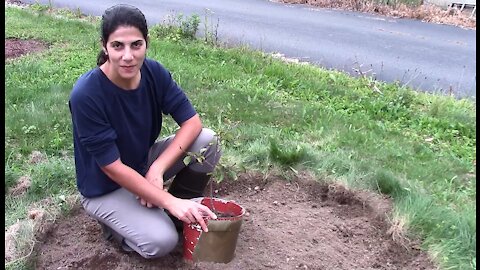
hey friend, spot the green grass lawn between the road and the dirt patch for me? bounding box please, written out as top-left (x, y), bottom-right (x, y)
top-left (5, 6), bottom-right (476, 269)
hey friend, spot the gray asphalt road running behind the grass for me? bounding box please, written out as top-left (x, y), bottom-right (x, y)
top-left (24, 0), bottom-right (476, 98)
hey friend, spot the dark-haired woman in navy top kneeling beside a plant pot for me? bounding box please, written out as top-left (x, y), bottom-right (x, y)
top-left (69, 5), bottom-right (221, 258)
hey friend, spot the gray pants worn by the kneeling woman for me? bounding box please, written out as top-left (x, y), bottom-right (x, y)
top-left (81, 128), bottom-right (221, 258)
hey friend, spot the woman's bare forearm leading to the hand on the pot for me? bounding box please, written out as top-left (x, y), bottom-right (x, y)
top-left (102, 159), bottom-right (175, 209)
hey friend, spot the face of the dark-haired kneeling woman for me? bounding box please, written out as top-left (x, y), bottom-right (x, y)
top-left (105, 26), bottom-right (147, 84)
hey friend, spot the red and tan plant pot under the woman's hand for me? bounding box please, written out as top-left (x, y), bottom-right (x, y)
top-left (183, 197), bottom-right (245, 263)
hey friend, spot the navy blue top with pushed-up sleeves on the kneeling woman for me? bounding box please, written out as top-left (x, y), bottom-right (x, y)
top-left (69, 59), bottom-right (196, 198)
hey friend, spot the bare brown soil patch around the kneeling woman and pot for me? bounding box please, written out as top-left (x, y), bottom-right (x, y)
top-left (31, 175), bottom-right (435, 269)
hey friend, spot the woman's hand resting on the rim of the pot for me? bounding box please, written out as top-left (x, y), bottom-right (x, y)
top-left (167, 197), bottom-right (217, 232)
